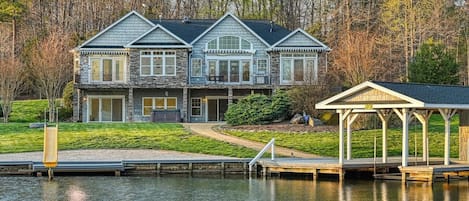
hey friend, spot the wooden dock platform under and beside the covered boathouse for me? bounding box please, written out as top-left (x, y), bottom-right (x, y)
top-left (254, 157), bottom-right (469, 182)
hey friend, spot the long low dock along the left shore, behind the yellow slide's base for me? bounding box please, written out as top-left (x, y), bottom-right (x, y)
top-left (0, 159), bottom-right (250, 176)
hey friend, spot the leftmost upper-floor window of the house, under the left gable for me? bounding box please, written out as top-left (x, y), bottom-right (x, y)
top-left (90, 57), bottom-right (124, 82)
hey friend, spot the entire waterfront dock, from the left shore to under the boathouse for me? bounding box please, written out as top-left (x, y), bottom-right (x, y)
top-left (0, 157), bottom-right (469, 182)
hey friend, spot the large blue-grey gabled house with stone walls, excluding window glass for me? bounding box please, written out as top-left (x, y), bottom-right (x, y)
top-left (73, 12), bottom-right (329, 122)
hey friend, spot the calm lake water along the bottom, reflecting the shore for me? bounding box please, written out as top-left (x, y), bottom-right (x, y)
top-left (0, 176), bottom-right (469, 201)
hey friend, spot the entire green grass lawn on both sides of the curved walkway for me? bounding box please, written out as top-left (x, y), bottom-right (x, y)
top-left (0, 100), bottom-right (459, 158)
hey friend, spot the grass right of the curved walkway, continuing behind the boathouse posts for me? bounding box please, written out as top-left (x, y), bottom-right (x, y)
top-left (224, 115), bottom-right (459, 158)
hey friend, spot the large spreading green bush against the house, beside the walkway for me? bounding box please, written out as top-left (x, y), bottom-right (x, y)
top-left (225, 90), bottom-right (290, 125)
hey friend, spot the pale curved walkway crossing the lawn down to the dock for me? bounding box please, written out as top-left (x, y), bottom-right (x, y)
top-left (183, 123), bottom-right (321, 158)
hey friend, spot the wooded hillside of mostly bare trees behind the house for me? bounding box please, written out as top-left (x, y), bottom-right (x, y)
top-left (0, 0), bottom-right (469, 95)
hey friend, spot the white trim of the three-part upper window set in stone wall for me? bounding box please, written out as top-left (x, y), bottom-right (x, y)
top-left (140, 50), bottom-right (177, 77)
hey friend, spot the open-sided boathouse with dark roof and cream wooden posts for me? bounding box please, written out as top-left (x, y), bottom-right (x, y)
top-left (316, 81), bottom-right (469, 180)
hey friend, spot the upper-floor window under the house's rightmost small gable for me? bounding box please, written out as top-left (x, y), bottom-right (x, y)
top-left (280, 54), bottom-right (318, 84)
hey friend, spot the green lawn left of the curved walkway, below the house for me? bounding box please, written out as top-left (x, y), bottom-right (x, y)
top-left (0, 123), bottom-right (257, 158)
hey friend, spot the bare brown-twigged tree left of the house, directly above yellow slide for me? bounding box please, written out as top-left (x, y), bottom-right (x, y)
top-left (29, 31), bottom-right (72, 122)
